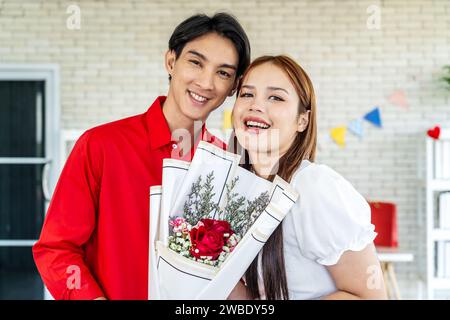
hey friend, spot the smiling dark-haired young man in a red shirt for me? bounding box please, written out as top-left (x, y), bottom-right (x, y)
top-left (33, 13), bottom-right (250, 299)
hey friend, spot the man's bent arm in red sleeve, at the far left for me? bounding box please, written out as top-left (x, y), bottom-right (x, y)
top-left (33, 131), bottom-right (104, 299)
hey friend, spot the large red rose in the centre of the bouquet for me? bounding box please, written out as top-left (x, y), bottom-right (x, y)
top-left (190, 219), bottom-right (233, 260)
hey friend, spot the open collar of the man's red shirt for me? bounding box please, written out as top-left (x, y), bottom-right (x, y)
top-left (146, 96), bottom-right (215, 150)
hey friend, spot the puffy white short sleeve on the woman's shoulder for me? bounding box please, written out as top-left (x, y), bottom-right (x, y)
top-left (292, 164), bottom-right (377, 265)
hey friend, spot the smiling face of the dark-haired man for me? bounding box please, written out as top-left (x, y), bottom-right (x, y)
top-left (166, 33), bottom-right (239, 121)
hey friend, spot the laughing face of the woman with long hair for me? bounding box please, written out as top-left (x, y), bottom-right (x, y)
top-left (233, 62), bottom-right (307, 157)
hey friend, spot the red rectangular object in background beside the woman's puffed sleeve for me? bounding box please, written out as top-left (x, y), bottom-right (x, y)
top-left (369, 201), bottom-right (398, 248)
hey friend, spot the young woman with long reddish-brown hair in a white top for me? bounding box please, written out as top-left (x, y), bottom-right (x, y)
top-left (230, 56), bottom-right (386, 299)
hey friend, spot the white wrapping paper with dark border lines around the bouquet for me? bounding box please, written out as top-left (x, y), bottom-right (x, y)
top-left (148, 142), bottom-right (298, 300)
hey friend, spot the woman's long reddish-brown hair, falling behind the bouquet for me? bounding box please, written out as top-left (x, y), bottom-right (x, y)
top-left (231, 55), bottom-right (317, 300)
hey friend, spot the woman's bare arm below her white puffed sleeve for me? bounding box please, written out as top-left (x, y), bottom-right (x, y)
top-left (323, 243), bottom-right (387, 300)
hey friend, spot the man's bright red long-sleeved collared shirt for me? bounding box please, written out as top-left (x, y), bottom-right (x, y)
top-left (33, 97), bottom-right (226, 300)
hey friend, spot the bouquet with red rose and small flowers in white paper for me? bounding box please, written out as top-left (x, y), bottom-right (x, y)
top-left (149, 142), bottom-right (298, 299)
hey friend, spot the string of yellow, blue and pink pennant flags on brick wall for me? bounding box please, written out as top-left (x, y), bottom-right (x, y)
top-left (330, 90), bottom-right (409, 147)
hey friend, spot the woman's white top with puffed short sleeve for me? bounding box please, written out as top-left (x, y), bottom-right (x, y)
top-left (259, 160), bottom-right (377, 299)
